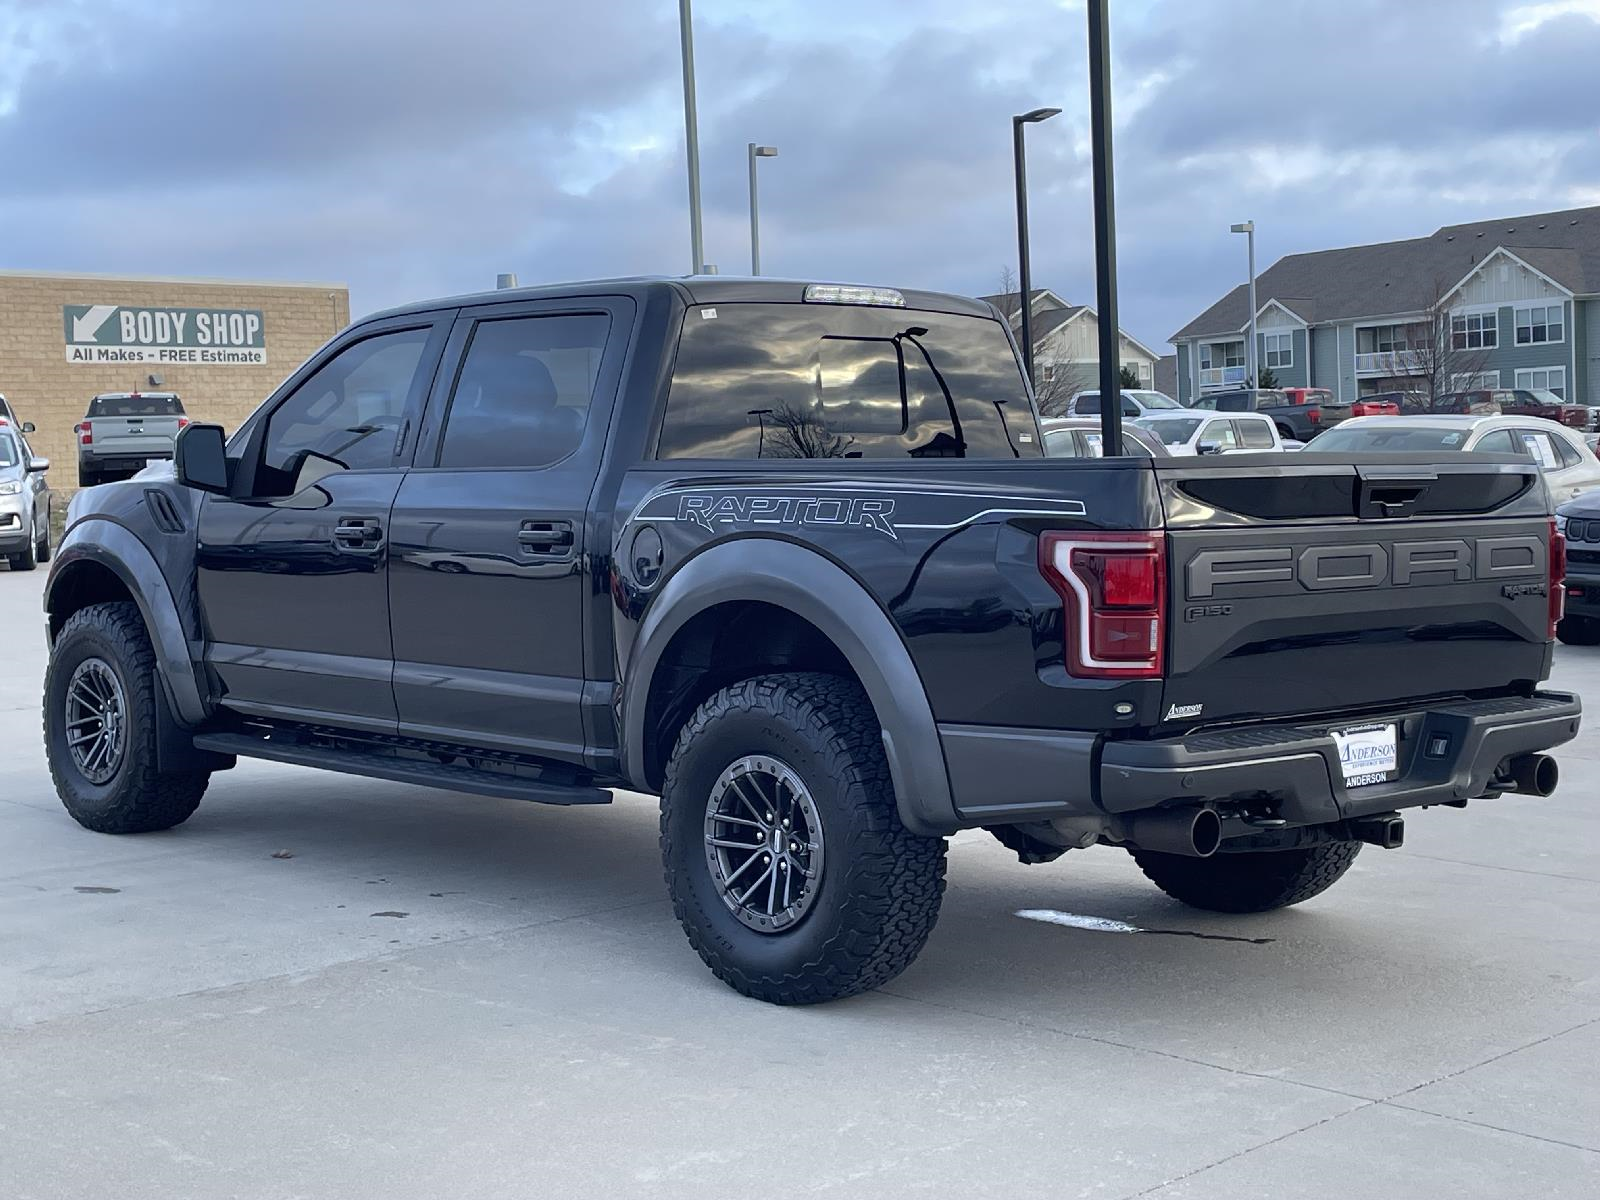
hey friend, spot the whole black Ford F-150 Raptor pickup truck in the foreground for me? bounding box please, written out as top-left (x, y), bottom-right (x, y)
top-left (43, 278), bottom-right (1579, 1003)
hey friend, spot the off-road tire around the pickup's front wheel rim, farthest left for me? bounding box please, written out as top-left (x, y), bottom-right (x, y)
top-left (45, 602), bottom-right (211, 834)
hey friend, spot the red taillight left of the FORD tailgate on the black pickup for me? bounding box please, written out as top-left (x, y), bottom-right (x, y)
top-left (1038, 530), bottom-right (1166, 678)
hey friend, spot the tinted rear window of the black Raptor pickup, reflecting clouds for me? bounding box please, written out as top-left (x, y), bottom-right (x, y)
top-left (658, 304), bottom-right (1043, 458)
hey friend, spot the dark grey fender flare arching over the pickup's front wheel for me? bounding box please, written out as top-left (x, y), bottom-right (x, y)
top-left (45, 517), bottom-right (208, 726)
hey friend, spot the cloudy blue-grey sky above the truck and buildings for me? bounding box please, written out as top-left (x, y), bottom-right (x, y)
top-left (0, 0), bottom-right (1600, 349)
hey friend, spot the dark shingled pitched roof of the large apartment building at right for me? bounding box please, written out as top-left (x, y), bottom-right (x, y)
top-left (1173, 208), bottom-right (1600, 341)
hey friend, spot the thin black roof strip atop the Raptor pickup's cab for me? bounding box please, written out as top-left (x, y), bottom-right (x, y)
top-left (362, 275), bottom-right (995, 322)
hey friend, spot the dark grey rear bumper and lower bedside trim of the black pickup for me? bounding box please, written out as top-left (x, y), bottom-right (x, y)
top-left (941, 693), bottom-right (1582, 826)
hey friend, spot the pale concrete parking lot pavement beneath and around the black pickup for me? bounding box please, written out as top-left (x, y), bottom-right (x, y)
top-left (0, 570), bottom-right (1600, 1198)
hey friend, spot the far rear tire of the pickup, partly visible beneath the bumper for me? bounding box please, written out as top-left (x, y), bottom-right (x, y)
top-left (1128, 842), bottom-right (1362, 912)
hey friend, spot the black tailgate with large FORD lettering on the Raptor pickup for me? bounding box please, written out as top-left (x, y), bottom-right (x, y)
top-left (1154, 453), bottom-right (1552, 726)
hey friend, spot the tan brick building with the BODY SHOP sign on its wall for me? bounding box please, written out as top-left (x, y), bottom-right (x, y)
top-left (0, 270), bottom-right (350, 491)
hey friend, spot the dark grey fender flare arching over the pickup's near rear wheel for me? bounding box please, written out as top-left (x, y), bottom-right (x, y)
top-left (621, 538), bottom-right (962, 837)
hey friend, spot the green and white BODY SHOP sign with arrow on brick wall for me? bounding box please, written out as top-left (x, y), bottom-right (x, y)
top-left (61, 304), bottom-right (267, 366)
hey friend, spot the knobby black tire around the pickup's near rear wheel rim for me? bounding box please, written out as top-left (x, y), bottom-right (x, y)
top-left (661, 674), bottom-right (944, 1005)
